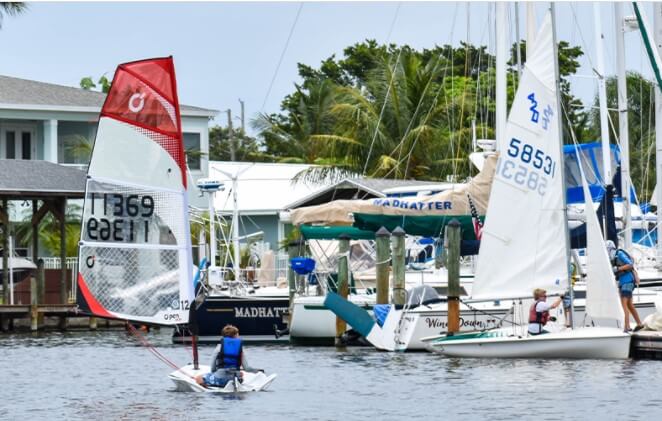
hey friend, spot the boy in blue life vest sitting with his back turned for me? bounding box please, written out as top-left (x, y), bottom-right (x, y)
top-left (195, 325), bottom-right (251, 387)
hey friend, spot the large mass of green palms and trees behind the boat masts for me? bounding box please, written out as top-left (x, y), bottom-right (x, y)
top-left (253, 40), bottom-right (586, 181)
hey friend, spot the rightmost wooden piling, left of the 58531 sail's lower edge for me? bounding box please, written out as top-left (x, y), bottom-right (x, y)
top-left (444, 219), bottom-right (462, 333)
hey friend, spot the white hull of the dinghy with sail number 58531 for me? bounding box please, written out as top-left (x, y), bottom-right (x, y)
top-left (428, 327), bottom-right (631, 359)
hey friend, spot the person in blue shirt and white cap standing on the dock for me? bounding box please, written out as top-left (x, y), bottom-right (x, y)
top-left (606, 240), bottom-right (644, 332)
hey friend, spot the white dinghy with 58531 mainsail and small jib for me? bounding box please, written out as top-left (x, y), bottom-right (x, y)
top-left (423, 9), bottom-right (631, 359)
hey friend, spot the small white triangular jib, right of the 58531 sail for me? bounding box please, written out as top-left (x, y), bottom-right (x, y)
top-left (578, 154), bottom-right (624, 321)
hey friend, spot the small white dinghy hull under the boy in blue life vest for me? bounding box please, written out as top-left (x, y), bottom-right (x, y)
top-left (168, 364), bottom-right (276, 393)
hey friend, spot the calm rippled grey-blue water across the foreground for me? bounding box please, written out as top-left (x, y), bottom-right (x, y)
top-left (0, 329), bottom-right (662, 421)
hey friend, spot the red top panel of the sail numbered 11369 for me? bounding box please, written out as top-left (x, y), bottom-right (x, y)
top-left (101, 57), bottom-right (186, 187)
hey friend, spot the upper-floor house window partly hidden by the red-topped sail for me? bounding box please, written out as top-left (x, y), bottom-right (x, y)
top-left (57, 121), bottom-right (97, 165)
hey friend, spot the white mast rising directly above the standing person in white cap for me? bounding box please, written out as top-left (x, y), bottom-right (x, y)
top-left (614, 2), bottom-right (632, 250)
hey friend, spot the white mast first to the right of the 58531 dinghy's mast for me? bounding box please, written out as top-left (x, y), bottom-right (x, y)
top-left (593, 2), bottom-right (612, 186)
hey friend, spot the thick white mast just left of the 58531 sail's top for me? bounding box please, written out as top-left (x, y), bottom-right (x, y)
top-left (495, 2), bottom-right (509, 151)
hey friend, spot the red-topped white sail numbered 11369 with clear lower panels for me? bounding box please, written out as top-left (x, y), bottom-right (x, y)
top-left (77, 57), bottom-right (193, 325)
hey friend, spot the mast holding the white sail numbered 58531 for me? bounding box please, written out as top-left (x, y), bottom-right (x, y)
top-left (550, 2), bottom-right (575, 328)
